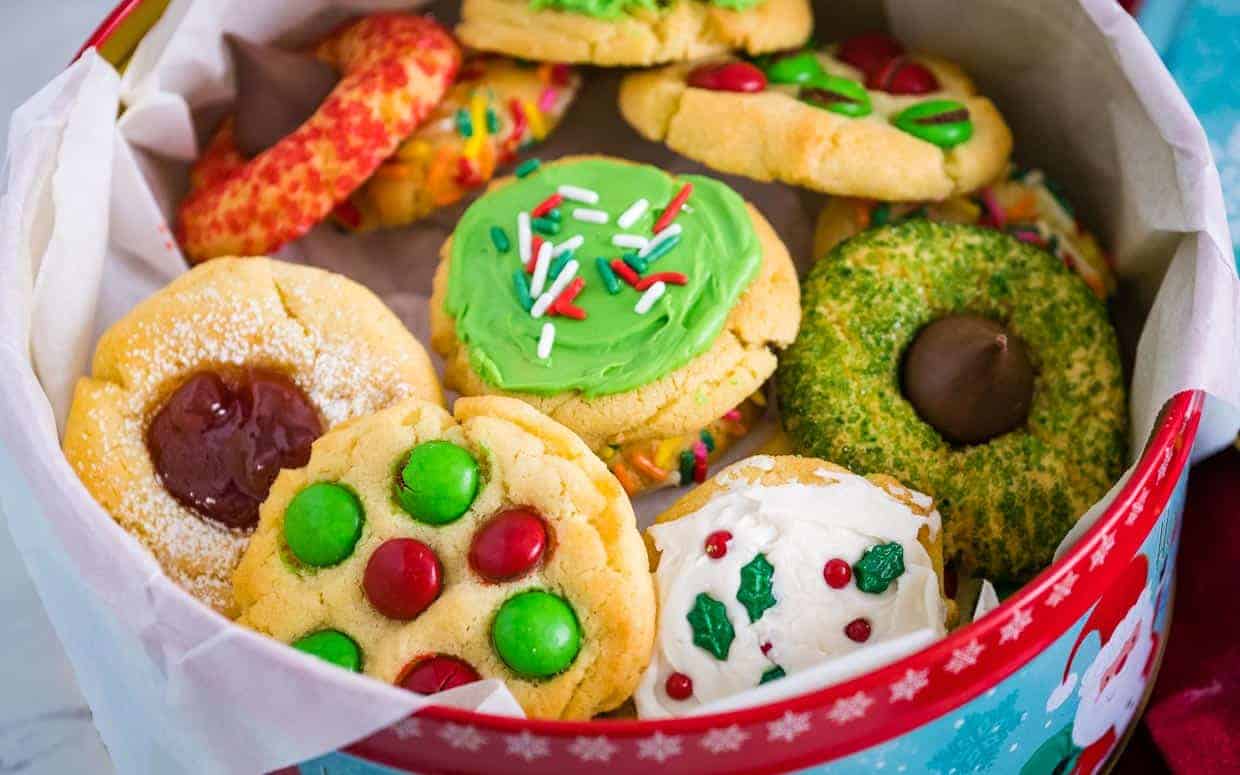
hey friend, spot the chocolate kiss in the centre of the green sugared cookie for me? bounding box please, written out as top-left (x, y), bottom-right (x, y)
top-left (904, 315), bottom-right (1034, 444)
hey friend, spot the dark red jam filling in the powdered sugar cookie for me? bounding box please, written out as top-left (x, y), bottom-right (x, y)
top-left (146, 370), bottom-right (324, 529)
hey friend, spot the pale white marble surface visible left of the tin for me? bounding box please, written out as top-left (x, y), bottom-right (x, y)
top-left (0, 0), bottom-right (117, 775)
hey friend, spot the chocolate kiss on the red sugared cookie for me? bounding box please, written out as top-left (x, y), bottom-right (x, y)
top-left (224, 35), bottom-right (340, 156)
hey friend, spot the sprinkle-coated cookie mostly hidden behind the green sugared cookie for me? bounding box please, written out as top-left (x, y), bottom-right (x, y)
top-left (813, 165), bottom-right (1116, 299)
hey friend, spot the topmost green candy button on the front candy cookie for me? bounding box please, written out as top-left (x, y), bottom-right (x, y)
top-left (397, 441), bottom-right (480, 525)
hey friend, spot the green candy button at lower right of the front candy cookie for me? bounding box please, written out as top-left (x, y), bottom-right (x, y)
top-left (491, 591), bottom-right (582, 678)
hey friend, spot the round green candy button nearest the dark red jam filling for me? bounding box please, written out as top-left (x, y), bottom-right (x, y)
top-left (284, 482), bottom-right (362, 568)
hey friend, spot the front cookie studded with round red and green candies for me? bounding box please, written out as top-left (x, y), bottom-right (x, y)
top-left (233, 397), bottom-right (655, 719)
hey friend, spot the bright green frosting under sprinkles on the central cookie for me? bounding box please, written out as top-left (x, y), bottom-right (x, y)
top-left (444, 159), bottom-right (761, 396)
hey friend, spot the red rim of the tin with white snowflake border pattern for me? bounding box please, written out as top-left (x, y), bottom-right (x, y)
top-left (74, 0), bottom-right (1205, 771)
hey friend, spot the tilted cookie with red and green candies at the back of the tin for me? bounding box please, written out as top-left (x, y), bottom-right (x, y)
top-left (620, 36), bottom-right (1012, 201)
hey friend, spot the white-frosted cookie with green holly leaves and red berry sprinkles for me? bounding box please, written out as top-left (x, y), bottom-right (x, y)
top-left (635, 456), bottom-right (954, 718)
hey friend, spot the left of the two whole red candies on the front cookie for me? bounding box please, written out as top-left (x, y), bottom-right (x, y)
top-left (362, 538), bottom-right (444, 620)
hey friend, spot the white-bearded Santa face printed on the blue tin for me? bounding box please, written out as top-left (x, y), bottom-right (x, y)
top-left (1073, 590), bottom-right (1156, 748)
